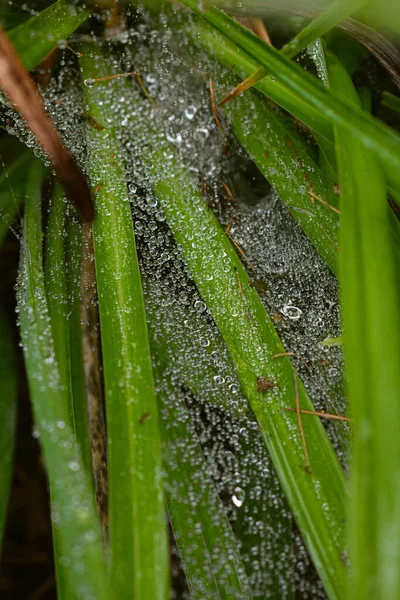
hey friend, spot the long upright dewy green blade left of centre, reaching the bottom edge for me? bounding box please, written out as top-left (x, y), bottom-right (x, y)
top-left (81, 47), bottom-right (168, 600)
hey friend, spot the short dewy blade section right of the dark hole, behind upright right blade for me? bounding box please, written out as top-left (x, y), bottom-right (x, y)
top-left (220, 79), bottom-right (339, 273)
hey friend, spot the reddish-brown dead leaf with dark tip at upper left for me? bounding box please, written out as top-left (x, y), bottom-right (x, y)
top-left (0, 27), bottom-right (94, 221)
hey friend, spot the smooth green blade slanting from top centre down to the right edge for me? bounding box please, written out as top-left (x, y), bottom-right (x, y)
top-left (181, 0), bottom-right (400, 188)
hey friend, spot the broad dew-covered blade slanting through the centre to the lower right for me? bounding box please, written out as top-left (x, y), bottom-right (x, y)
top-left (130, 94), bottom-right (346, 598)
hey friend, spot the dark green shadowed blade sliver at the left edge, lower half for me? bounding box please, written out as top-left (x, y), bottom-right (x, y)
top-left (0, 306), bottom-right (17, 548)
